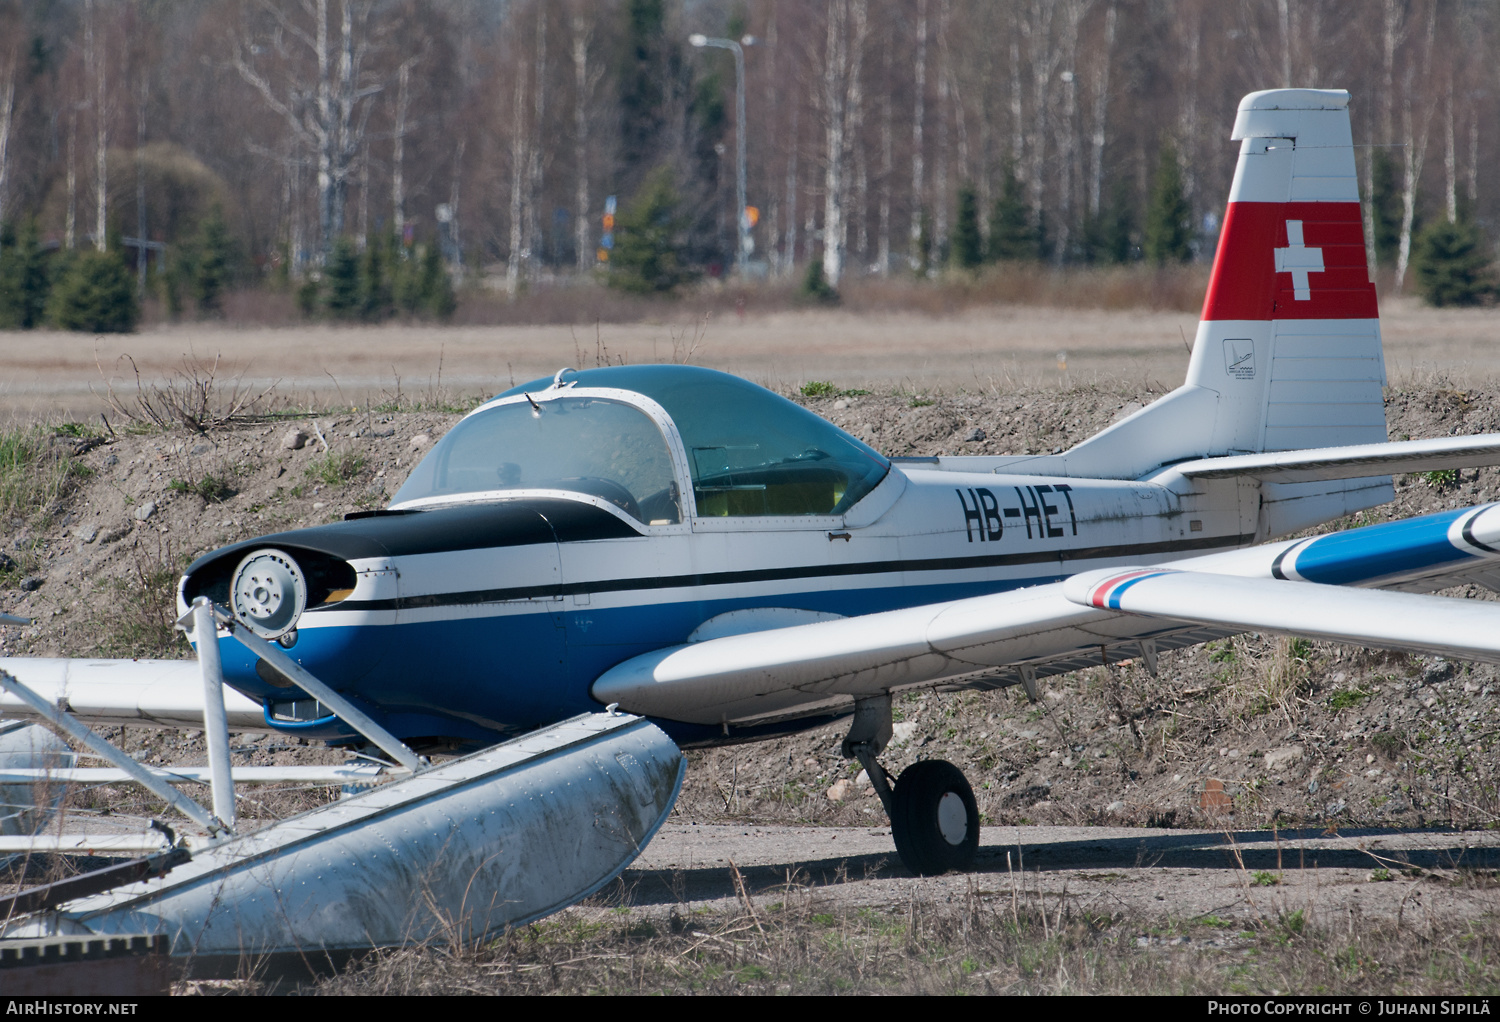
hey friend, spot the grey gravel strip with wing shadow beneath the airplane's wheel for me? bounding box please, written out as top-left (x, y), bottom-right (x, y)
top-left (623, 822), bottom-right (1500, 924)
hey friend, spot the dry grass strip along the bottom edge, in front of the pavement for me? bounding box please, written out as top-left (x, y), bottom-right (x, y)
top-left (308, 882), bottom-right (1500, 995)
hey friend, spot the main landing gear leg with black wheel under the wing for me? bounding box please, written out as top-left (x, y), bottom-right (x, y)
top-left (842, 695), bottom-right (980, 876)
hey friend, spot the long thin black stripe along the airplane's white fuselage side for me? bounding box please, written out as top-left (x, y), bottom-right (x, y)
top-left (322, 534), bottom-right (1256, 612)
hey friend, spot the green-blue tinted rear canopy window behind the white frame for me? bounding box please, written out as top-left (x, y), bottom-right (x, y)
top-left (506, 366), bottom-right (891, 518)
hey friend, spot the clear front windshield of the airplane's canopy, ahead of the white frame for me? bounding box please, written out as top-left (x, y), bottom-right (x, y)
top-left (392, 398), bottom-right (681, 525)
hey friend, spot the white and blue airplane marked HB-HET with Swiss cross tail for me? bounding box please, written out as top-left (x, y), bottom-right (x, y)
top-left (0, 90), bottom-right (1500, 873)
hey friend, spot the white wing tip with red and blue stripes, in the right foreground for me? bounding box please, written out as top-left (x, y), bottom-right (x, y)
top-left (1062, 567), bottom-right (1500, 663)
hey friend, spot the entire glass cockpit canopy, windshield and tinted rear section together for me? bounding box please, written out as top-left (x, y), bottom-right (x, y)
top-left (393, 366), bottom-right (891, 525)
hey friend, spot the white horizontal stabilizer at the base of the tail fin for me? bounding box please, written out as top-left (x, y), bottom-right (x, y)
top-left (1172, 432), bottom-right (1500, 483)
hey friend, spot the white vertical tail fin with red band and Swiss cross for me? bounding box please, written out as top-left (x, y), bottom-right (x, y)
top-left (1068, 89), bottom-right (1386, 476)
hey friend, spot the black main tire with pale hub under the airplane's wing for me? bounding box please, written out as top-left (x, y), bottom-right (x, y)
top-left (891, 759), bottom-right (980, 876)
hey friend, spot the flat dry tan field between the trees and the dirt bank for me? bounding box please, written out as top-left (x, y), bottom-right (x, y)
top-left (0, 291), bottom-right (1500, 420)
